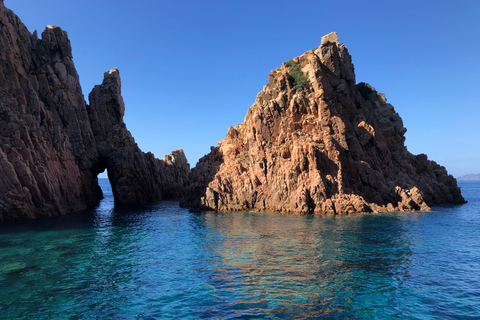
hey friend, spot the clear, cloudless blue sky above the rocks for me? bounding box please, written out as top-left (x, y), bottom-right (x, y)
top-left (5, 0), bottom-right (480, 177)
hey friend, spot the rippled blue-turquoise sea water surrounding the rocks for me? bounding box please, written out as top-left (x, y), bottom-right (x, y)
top-left (0, 179), bottom-right (480, 319)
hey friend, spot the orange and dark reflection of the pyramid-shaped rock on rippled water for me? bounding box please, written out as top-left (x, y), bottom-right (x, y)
top-left (192, 213), bottom-right (411, 317)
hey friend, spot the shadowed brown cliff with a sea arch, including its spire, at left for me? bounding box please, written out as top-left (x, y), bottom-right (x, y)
top-left (0, 0), bottom-right (190, 221)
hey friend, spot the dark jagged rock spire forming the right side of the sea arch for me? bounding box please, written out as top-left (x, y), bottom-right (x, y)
top-left (87, 69), bottom-right (190, 205)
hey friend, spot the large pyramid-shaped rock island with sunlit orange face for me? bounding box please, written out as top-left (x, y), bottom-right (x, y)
top-left (181, 33), bottom-right (465, 214)
